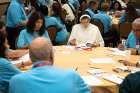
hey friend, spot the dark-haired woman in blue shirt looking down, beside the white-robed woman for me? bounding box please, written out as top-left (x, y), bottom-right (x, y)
top-left (17, 12), bottom-right (49, 49)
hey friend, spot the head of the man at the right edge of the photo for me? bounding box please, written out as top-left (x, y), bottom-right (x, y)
top-left (132, 18), bottom-right (140, 38)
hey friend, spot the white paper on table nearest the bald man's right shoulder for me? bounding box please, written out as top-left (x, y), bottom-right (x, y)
top-left (82, 75), bottom-right (103, 86)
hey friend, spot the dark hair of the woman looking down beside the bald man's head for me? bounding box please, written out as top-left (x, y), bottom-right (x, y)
top-left (27, 12), bottom-right (46, 36)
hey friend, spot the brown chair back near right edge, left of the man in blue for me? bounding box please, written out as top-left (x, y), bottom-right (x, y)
top-left (119, 23), bottom-right (132, 39)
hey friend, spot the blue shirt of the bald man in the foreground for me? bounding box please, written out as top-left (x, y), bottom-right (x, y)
top-left (9, 63), bottom-right (91, 93)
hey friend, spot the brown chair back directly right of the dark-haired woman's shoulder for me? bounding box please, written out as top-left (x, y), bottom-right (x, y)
top-left (47, 25), bottom-right (57, 45)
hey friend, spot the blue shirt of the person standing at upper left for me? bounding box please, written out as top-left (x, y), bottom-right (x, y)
top-left (6, 0), bottom-right (27, 28)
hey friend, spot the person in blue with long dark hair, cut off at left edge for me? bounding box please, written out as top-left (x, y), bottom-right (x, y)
top-left (0, 22), bottom-right (20, 93)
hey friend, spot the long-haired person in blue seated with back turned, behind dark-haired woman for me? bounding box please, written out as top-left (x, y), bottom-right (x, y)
top-left (45, 2), bottom-right (69, 45)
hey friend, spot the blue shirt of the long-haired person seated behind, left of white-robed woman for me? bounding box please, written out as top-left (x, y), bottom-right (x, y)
top-left (45, 16), bottom-right (68, 44)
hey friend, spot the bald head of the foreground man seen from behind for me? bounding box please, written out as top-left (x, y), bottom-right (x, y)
top-left (29, 37), bottom-right (54, 64)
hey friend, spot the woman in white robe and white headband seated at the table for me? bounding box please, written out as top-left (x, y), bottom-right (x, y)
top-left (68, 14), bottom-right (104, 47)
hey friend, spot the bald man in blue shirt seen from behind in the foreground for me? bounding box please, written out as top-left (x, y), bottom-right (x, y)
top-left (9, 37), bottom-right (91, 93)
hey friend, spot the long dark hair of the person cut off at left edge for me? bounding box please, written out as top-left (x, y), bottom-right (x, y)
top-left (0, 21), bottom-right (7, 58)
